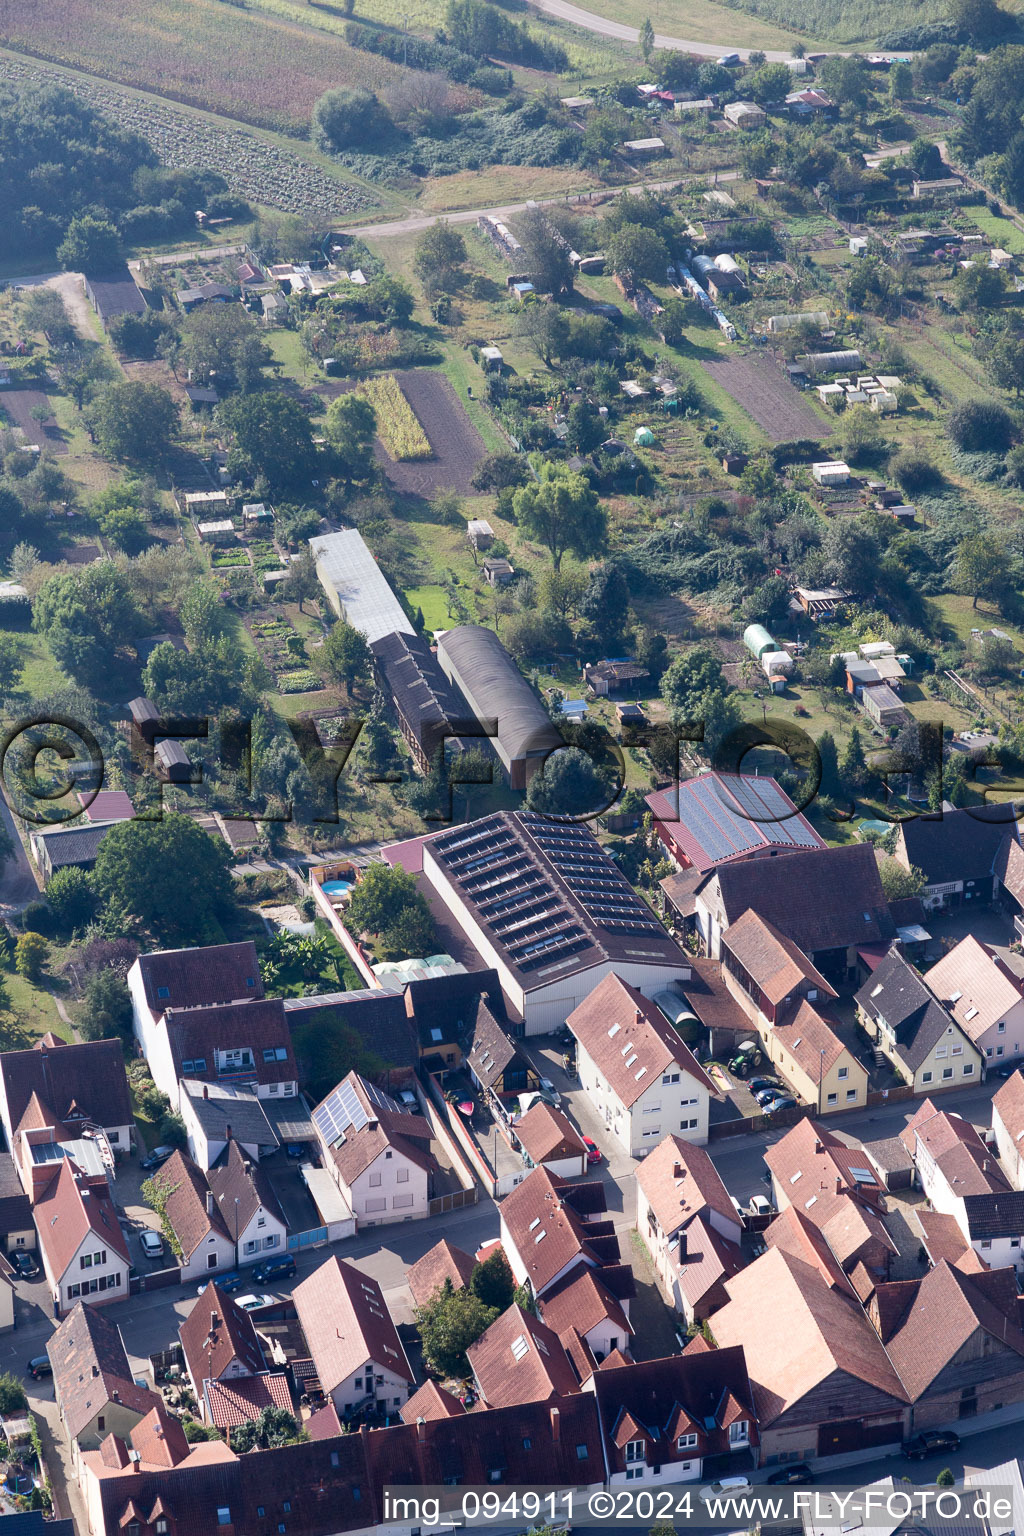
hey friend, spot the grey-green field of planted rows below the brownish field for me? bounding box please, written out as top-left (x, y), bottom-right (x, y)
top-left (0, 57), bottom-right (376, 218)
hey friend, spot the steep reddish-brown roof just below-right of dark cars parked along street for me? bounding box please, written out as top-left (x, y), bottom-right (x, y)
top-left (292, 1256), bottom-right (415, 1393)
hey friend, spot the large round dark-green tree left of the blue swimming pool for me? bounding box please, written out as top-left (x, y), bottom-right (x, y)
top-left (92, 813), bottom-right (235, 943)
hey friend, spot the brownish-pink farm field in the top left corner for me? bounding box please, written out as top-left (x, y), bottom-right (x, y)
top-left (0, 0), bottom-right (404, 132)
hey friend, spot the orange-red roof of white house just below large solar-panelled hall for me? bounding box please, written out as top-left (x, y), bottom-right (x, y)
top-left (567, 971), bottom-right (717, 1109)
